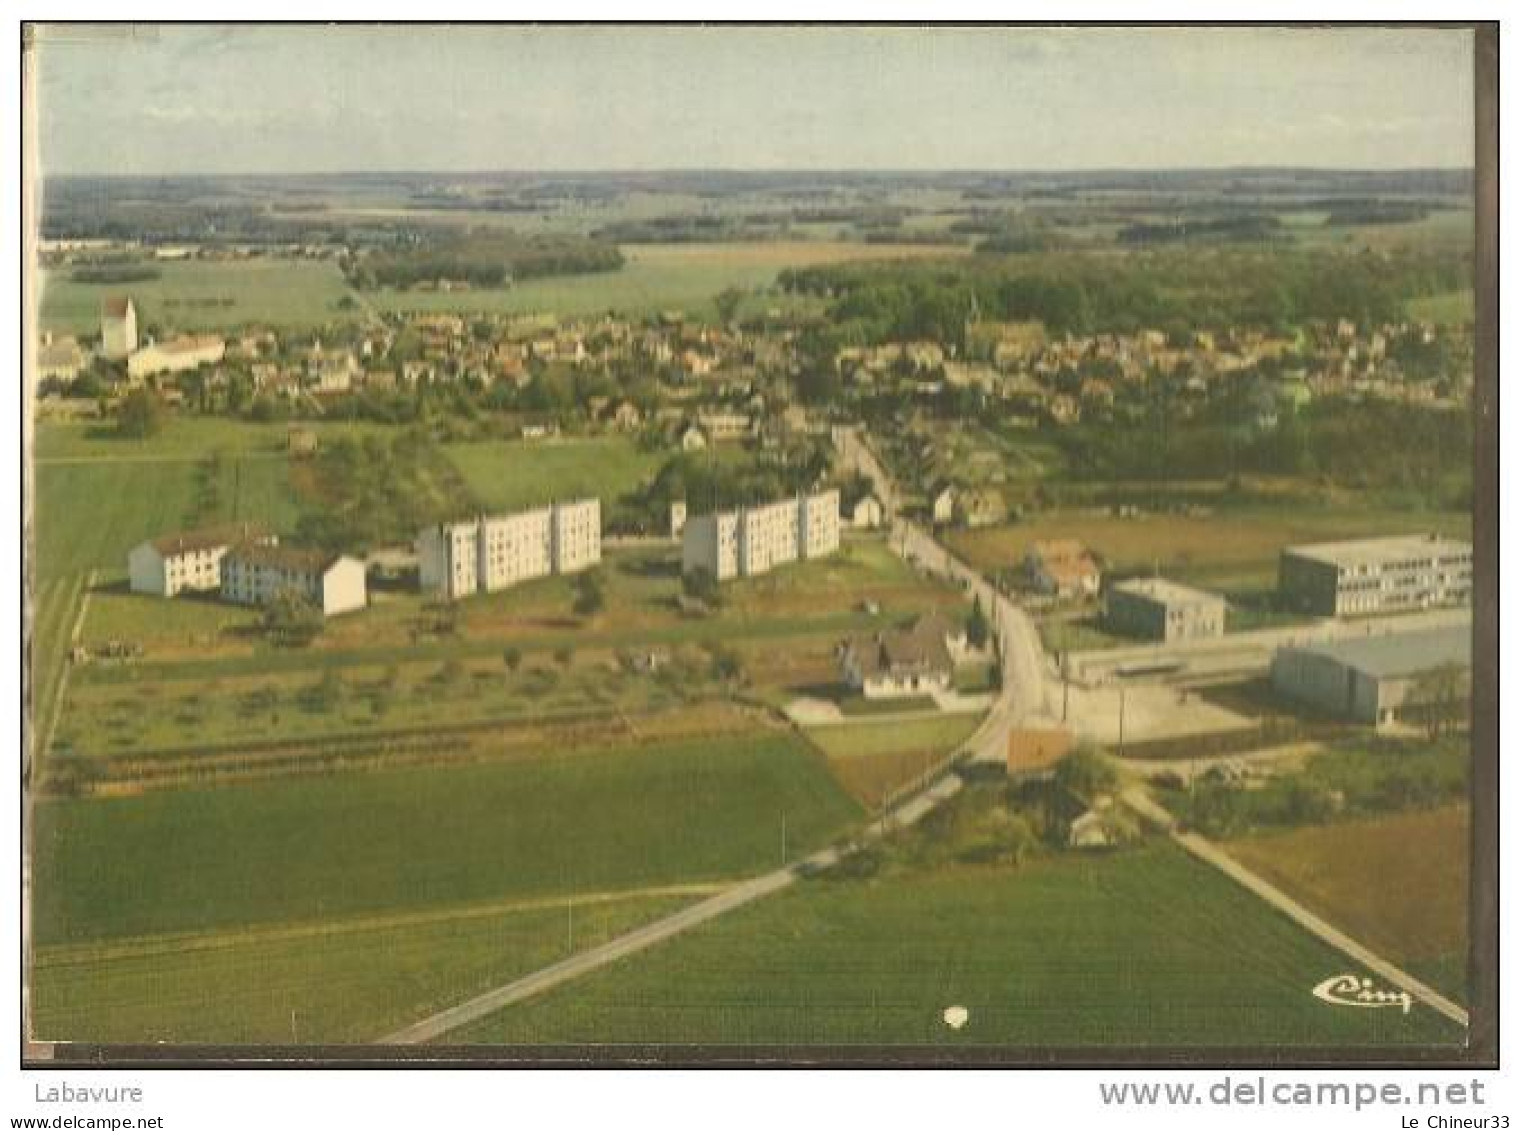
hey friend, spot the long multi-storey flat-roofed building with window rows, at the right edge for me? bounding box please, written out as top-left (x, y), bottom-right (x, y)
top-left (1277, 534), bottom-right (1473, 617)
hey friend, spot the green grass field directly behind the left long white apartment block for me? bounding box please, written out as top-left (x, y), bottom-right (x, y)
top-left (444, 436), bottom-right (669, 512)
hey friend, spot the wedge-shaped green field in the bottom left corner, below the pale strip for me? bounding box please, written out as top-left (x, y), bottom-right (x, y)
top-left (30, 894), bottom-right (690, 1044)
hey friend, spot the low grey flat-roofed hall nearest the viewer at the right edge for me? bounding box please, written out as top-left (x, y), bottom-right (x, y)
top-left (1272, 623), bottom-right (1473, 727)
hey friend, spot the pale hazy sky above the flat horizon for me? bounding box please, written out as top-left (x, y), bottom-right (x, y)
top-left (36, 26), bottom-right (1473, 175)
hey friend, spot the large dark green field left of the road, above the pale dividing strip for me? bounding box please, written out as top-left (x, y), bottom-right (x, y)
top-left (33, 734), bottom-right (860, 946)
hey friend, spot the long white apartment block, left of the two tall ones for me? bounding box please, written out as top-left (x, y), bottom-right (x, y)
top-left (416, 499), bottom-right (602, 599)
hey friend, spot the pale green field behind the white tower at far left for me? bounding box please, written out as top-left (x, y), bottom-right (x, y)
top-left (40, 258), bottom-right (359, 334)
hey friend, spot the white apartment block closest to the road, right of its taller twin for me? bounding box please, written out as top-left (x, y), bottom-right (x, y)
top-left (681, 491), bottom-right (839, 581)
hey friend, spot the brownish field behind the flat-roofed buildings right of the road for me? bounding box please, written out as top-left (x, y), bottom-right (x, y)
top-left (947, 506), bottom-right (1473, 588)
